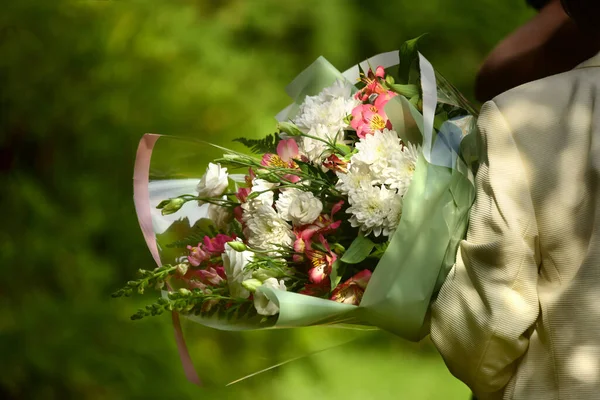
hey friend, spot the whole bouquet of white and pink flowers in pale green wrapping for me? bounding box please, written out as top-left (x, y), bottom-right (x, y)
top-left (115, 39), bottom-right (477, 360)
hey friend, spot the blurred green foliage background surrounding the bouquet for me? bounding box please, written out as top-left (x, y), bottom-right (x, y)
top-left (0, 0), bottom-right (534, 400)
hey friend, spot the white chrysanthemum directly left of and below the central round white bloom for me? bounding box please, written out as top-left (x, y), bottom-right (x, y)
top-left (242, 201), bottom-right (294, 255)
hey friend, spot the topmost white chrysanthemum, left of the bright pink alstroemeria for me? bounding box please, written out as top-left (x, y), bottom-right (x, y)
top-left (294, 81), bottom-right (360, 135)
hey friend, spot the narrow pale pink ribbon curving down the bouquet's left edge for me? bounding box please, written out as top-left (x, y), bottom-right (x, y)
top-left (133, 133), bottom-right (202, 386)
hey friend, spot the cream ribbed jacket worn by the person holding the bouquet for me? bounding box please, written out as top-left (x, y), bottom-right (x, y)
top-left (431, 54), bottom-right (600, 400)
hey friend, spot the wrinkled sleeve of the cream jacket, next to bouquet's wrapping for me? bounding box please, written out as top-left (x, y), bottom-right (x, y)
top-left (431, 102), bottom-right (539, 399)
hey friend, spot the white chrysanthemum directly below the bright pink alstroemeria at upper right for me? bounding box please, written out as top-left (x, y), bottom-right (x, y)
top-left (350, 129), bottom-right (402, 183)
